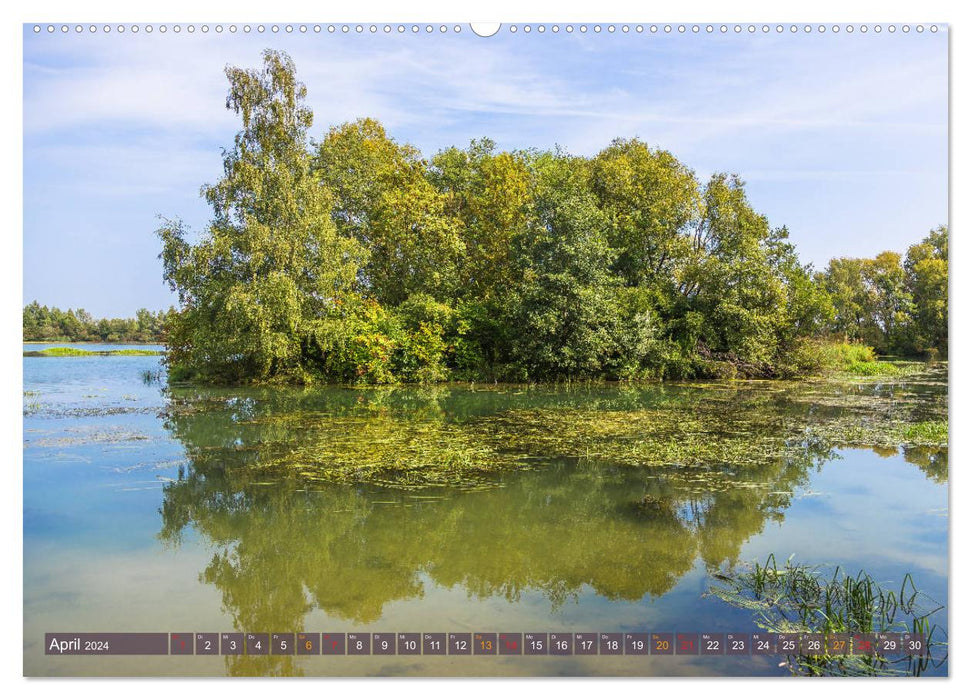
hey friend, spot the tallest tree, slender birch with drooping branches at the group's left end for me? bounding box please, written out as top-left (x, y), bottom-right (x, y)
top-left (158, 50), bottom-right (364, 381)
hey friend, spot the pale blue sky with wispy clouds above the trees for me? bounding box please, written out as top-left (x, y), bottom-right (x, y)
top-left (23, 26), bottom-right (948, 316)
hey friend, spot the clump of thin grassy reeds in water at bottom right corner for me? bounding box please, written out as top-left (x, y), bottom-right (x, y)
top-left (705, 555), bottom-right (947, 676)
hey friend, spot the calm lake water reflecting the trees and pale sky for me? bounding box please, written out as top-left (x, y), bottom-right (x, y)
top-left (23, 345), bottom-right (948, 675)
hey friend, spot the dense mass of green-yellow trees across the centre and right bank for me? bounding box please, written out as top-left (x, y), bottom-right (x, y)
top-left (159, 51), bottom-right (947, 383)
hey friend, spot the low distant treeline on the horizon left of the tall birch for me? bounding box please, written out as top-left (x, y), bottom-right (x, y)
top-left (24, 301), bottom-right (170, 343)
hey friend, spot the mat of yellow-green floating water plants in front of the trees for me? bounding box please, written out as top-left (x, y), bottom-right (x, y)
top-left (161, 372), bottom-right (947, 488)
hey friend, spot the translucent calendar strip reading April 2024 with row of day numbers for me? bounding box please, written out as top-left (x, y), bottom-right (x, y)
top-left (44, 632), bottom-right (928, 657)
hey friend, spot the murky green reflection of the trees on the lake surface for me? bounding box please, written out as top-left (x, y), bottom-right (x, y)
top-left (160, 380), bottom-right (946, 675)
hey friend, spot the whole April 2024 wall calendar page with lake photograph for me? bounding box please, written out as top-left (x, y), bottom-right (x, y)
top-left (22, 16), bottom-right (950, 688)
